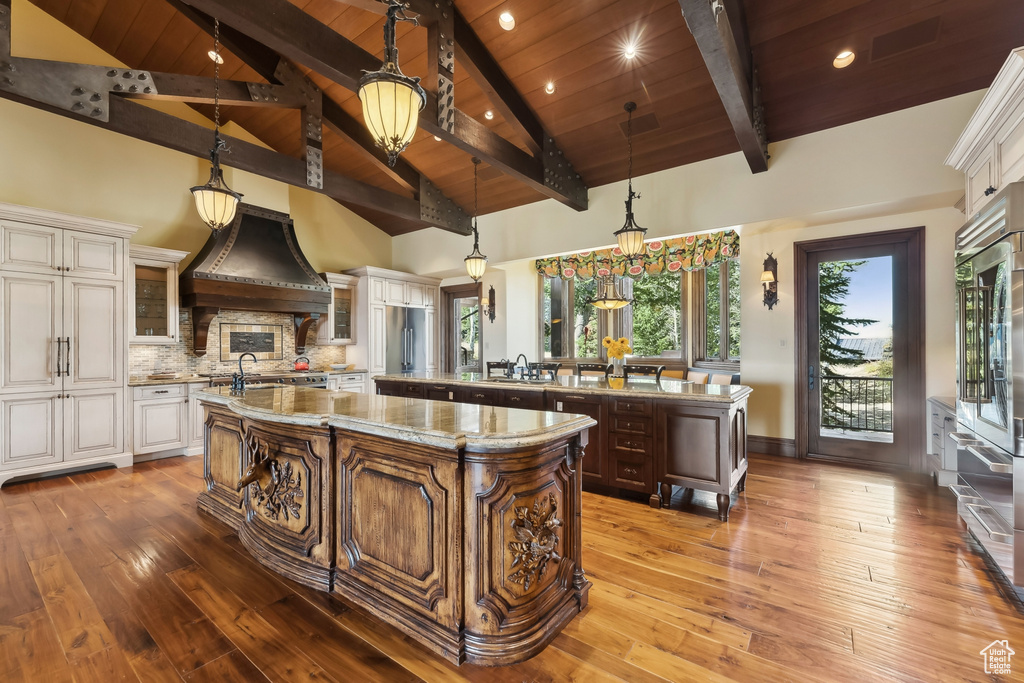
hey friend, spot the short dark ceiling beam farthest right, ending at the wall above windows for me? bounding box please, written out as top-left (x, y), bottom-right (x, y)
top-left (679, 0), bottom-right (768, 173)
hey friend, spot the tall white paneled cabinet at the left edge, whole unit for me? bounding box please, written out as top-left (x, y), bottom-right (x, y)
top-left (0, 204), bottom-right (136, 484)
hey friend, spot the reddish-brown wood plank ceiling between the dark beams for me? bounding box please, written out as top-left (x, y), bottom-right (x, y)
top-left (14, 0), bottom-right (1024, 233)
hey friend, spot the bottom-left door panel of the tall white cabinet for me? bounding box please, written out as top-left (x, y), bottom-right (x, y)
top-left (0, 391), bottom-right (66, 470)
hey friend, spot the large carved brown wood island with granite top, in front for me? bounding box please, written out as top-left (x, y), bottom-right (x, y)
top-left (198, 387), bottom-right (594, 666)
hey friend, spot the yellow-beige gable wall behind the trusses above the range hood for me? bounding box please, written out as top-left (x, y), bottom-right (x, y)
top-left (0, 0), bottom-right (391, 270)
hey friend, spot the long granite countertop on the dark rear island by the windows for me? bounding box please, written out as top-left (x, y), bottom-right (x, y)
top-left (374, 373), bottom-right (752, 403)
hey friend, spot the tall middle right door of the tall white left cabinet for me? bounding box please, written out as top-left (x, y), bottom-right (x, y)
top-left (63, 278), bottom-right (124, 389)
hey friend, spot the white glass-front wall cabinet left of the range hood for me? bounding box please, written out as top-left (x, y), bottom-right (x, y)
top-left (128, 245), bottom-right (188, 344)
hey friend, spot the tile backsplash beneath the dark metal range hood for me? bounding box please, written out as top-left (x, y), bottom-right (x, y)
top-left (128, 309), bottom-right (345, 375)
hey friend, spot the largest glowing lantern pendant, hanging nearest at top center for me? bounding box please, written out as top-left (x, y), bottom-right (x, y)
top-left (358, 0), bottom-right (427, 166)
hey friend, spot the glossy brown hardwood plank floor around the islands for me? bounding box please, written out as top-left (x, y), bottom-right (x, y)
top-left (0, 456), bottom-right (1024, 683)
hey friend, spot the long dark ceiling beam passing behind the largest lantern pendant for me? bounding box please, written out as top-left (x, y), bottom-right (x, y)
top-left (183, 0), bottom-right (587, 211)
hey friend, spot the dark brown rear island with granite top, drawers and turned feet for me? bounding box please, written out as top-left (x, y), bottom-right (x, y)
top-left (374, 373), bottom-right (751, 521)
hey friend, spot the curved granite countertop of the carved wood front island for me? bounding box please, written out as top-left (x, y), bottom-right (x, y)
top-left (193, 386), bottom-right (597, 451)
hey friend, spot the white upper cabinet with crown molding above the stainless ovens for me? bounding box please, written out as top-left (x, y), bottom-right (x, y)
top-left (946, 48), bottom-right (1024, 219)
